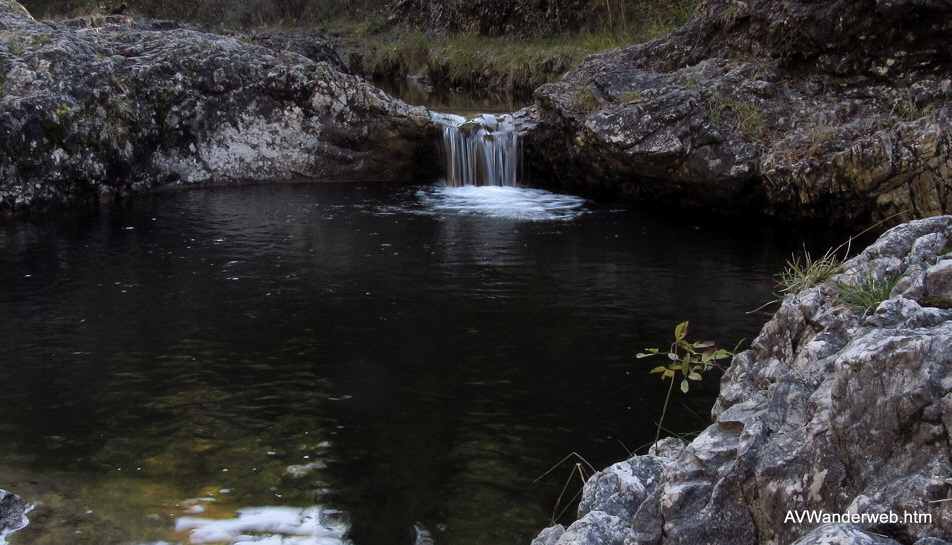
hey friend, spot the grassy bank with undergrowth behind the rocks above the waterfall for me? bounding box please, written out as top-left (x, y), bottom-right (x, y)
top-left (24, 0), bottom-right (699, 95)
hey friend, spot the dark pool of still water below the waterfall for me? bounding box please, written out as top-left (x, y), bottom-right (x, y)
top-left (0, 183), bottom-right (795, 545)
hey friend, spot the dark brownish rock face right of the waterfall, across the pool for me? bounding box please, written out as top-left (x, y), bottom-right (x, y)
top-left (526, 0), bottom-right (952, 224)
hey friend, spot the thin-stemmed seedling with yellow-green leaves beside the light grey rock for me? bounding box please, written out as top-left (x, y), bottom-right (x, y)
top-left (635, 322), bottom-right (734, 443)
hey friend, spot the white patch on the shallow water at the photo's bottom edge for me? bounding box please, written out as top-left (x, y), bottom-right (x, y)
top-left (175, 506), bottom-right (349, 545)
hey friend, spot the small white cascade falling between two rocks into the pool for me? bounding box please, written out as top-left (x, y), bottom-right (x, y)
top-left (434, 114), bottom-right (522, 187)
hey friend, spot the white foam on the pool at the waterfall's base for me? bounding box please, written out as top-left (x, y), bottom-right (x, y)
top-left (417, 185), bottom-right (585, 221)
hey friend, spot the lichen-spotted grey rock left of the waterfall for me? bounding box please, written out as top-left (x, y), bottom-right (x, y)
top-left (0, 0), bottom-right (437, 214)
